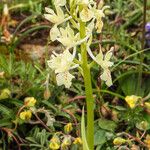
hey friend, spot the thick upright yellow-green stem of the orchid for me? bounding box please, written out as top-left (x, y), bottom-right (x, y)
top-left (80, 22), bottom-right (94, 150)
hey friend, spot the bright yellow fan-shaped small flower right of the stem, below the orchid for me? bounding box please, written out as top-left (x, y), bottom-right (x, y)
top-left (125, 95), bottom-right (140, 109)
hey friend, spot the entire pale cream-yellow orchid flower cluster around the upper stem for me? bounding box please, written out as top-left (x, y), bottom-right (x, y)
top-left (44, 0), bottom-right (113, 88)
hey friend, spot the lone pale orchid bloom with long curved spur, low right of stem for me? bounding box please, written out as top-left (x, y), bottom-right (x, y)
top-left (87, 46), bottom-right (113, 87)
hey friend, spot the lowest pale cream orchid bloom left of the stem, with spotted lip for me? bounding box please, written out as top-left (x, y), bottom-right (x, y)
top-left (48, 48), bottom-right (79, 88)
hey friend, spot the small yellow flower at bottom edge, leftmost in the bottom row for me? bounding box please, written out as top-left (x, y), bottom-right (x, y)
top-left (49, 135), bottom-right (60, 150)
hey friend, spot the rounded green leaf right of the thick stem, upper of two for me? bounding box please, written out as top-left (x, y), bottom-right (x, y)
top-left (98, 119), bottom-right (117, 132)
